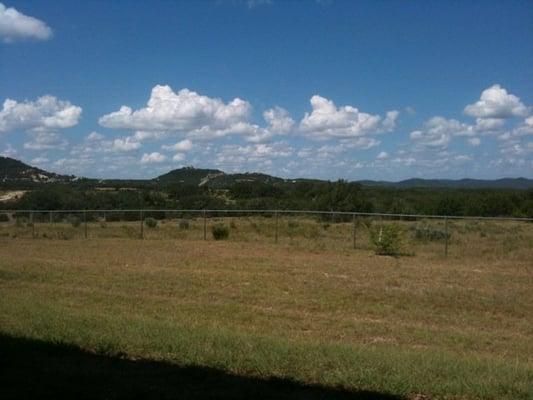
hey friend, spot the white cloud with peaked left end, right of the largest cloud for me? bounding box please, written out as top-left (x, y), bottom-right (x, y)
top-left (299, 95), bottom-right (399, 139)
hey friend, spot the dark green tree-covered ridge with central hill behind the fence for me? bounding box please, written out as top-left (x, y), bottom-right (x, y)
top-left (0, 157), bottom-right (533, 217)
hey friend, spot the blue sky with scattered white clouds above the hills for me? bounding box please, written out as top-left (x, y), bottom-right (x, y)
top-left (0, 0), bottom-right (533, 181)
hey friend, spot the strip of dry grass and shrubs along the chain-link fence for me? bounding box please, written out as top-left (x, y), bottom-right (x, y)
top-left (0, 209), bottom-right (533, 256)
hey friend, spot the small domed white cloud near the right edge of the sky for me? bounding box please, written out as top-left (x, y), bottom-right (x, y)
top-left (464, 85), bottom-right (528, 119)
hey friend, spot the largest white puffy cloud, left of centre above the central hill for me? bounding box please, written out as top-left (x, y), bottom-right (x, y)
top-left (99, 85), bottom-right (294, 143)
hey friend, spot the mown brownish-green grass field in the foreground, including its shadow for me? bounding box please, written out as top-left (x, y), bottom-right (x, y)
top-left (0, 218), bottom-right (533, 399)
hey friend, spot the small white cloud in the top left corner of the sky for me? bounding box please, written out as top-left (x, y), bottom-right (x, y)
top-left (0, 3), bottom-right (52, 43)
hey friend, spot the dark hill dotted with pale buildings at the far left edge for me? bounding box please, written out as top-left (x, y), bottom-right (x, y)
top-left (0, 156), bottom-right (78, 184)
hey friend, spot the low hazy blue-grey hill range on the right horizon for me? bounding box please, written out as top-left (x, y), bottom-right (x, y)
top-left (358, 178), bottom-right (533, 189)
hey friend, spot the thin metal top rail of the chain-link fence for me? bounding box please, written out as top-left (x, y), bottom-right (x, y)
top-left (0, 208), bottom-right (533, 222)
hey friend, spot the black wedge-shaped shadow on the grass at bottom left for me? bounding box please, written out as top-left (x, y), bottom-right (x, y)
top-left (0, 334), bottom-right (400, 400)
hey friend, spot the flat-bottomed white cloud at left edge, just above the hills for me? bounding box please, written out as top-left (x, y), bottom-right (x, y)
top-left (0, 96), bottom-right (82, 132)
